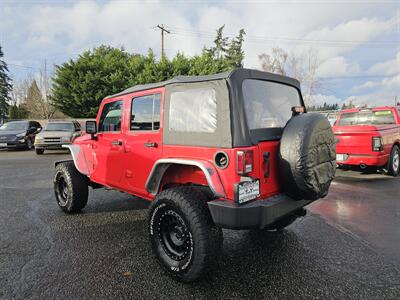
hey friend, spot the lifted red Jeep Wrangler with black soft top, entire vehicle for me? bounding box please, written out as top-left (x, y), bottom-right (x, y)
top-left (54, 69), bottom-right (336, 281)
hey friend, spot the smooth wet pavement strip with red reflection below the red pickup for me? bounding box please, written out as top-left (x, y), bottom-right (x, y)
top-left (309, 170), bottom-right (400, 266)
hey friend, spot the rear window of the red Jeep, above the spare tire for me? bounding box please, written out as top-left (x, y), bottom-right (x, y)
top-left (242, 79), bottom-right (301, 129)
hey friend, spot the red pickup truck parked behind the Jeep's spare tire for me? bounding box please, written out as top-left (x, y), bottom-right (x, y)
top-left (333, 106), bottom-right (400, 176)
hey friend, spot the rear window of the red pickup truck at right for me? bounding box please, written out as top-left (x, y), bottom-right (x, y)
top-left (339, 110), bottom-right (396, 126)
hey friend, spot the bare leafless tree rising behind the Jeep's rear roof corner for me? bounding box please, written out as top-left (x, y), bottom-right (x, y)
top-left (258, 48), bottom-right (323, 106)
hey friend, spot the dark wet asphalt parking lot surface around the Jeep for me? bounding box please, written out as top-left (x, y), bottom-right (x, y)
top-left (0, 151), bottom-right (400, 299)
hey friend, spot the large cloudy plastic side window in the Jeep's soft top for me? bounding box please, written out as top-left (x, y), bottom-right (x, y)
top-left (169, 88), bottom-right (217, 133)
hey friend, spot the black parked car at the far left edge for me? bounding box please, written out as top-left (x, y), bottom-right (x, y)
top-left (0, 121), bottom-right (42, 150)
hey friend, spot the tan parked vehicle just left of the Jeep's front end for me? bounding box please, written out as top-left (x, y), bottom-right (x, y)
top-left (35, 121), bottom-right (82, 155)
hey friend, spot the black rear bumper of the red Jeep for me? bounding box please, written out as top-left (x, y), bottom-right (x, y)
top-left (208, 194), bottom-right (312, 229)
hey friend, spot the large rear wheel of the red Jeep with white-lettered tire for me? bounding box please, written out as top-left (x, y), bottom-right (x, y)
top-left (148, 187), bottom-right (222, 282)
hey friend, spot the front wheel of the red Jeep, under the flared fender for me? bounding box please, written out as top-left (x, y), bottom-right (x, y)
top-left (54, 161), bottom-right (89, 213)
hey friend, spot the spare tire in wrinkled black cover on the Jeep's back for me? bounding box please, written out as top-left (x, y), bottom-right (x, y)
top-left (279, 113), bottom-right (336, 200)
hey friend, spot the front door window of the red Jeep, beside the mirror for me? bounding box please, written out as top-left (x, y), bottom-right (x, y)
top-left (99, 100), bottom-right (123, 132)
